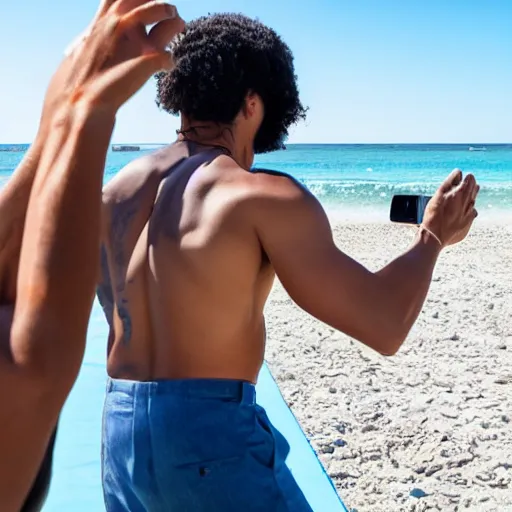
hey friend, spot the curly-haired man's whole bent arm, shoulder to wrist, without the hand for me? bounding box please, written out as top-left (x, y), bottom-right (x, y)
top-left (256, 170), bottom-right (474, 355)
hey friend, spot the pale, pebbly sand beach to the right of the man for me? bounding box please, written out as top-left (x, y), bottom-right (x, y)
top-left (267, 222), bottom-right (512, 512)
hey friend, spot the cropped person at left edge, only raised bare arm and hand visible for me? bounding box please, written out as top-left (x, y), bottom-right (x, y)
top-left (0, 0), bottom-right (183, 512)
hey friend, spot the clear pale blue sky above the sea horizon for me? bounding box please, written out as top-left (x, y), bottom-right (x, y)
top-left (0, 0), bottom-right (512, 143)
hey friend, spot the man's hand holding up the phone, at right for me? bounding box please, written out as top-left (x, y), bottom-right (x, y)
top-left (422, 169), bottom-right (480, 247)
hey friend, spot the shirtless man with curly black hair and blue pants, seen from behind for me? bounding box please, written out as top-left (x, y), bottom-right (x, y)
top-left (98, 15), bottom-right (478, 512)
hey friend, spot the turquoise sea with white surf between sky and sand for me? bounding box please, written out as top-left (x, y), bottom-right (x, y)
top-left (0, 144), bottom-right (512, 221)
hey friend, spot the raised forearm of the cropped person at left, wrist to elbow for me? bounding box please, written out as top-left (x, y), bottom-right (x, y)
top-left (11, 103), bottom-right (115, 383)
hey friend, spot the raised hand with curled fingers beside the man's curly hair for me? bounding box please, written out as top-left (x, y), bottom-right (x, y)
top-left (41, 0), bottom-right (185, 125)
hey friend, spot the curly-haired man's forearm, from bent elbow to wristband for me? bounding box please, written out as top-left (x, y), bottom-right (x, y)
top-left (377, 231), bottom-right (441, 353)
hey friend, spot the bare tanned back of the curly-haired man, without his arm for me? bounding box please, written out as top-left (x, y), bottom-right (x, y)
top-left (98, 141), bottom-right (282, 382)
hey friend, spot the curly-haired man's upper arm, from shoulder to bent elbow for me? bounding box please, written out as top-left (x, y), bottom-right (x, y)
top-left (255, 174), bottom-right (396, 352)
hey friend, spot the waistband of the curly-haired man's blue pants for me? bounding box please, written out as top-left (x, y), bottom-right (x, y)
top-left (107, 377), bottom-right (256, 405)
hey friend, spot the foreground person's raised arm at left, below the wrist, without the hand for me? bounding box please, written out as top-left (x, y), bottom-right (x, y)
top-left (0, 105), bottom-right (113, 511)
